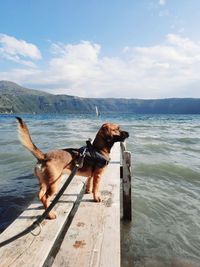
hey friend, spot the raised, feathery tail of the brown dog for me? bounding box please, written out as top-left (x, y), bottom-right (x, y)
top-left (16, 117), bottom-right (45, 160)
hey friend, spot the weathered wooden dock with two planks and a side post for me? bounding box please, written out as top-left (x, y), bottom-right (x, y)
top-left (0, 143), bottom-right (131, 267)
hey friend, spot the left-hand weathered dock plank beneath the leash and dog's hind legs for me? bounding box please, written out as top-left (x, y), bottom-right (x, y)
top-left (0, 176), bottom-right (85, 267)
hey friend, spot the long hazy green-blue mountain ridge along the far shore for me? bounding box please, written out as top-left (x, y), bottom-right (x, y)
top-left (0, 81), bottom-right (200, 114)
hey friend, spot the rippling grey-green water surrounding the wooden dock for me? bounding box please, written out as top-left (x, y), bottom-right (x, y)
top-left (0, 114), bottom-right (200, 267)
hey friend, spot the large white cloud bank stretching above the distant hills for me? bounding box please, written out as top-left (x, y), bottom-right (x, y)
top-left (0, 34), bottom-right (200, 98)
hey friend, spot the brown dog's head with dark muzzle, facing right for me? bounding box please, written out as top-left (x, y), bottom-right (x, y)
top-left (99, 123), bottom-right (129, 143)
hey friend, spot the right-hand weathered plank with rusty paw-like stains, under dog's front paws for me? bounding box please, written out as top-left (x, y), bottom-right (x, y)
top-left (52, 144), bottom-right (120, 267)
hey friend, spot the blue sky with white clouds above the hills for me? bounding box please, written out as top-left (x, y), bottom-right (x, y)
top-left (0, 0), bottom-right (200, 99)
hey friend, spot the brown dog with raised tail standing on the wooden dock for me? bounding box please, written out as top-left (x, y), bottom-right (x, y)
top-left (16, 117), bottom-right (129, 219)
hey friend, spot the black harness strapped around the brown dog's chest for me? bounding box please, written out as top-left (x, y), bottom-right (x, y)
top-left (79, 141), bottom-right (110, 169)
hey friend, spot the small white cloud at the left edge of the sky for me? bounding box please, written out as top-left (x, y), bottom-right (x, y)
top-left (0, 34), bottom-right (41, 67)
